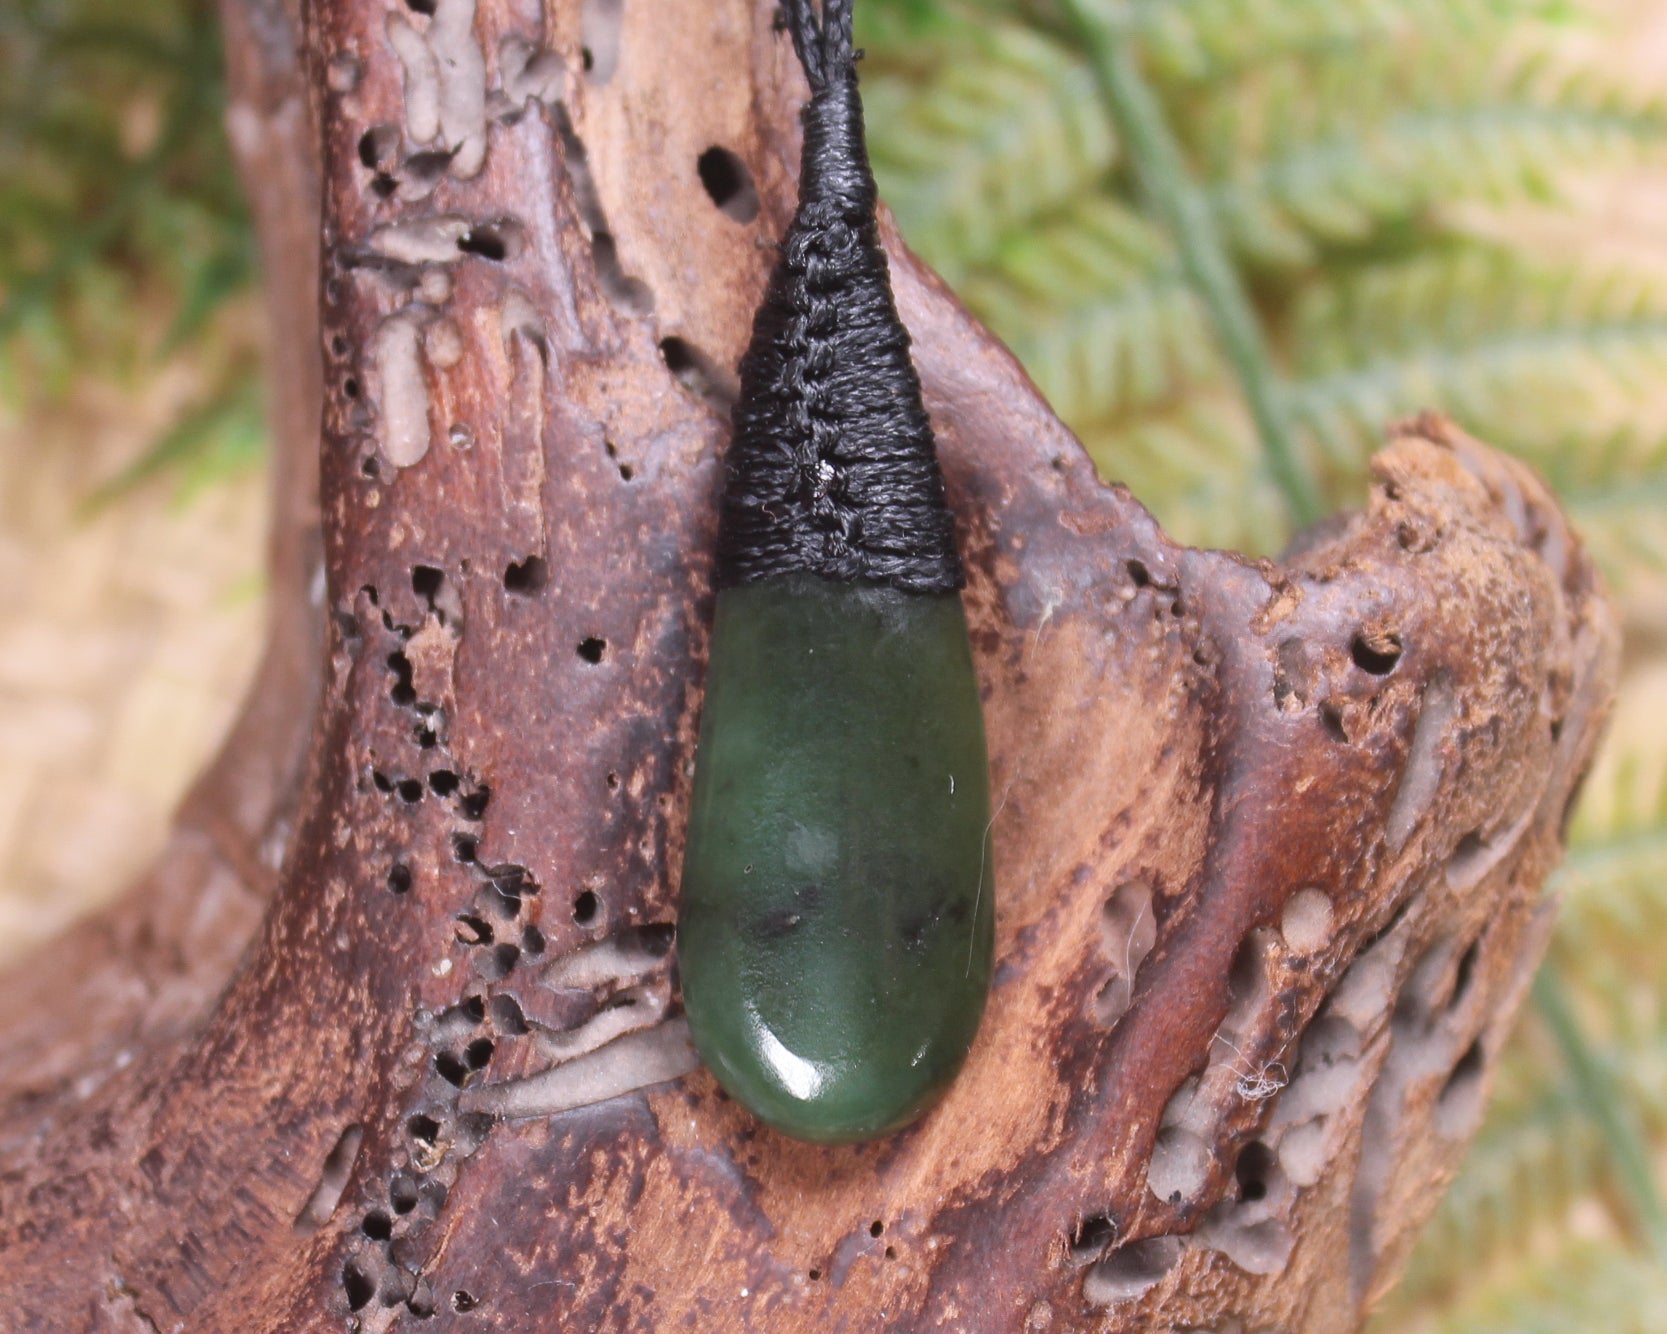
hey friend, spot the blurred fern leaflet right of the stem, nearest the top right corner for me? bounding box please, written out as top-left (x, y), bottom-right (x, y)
top-left (1174, 23), bottom-right (1667, 265)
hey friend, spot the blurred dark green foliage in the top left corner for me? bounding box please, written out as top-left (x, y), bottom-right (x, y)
top-left (0, 0), bottom-right (263, 504)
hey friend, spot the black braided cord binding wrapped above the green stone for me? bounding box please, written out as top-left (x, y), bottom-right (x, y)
top-left (717, 0), bottom-right (964, 594)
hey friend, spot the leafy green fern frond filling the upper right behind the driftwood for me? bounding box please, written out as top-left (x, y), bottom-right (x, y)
top-left (875, 0), bottom-right (1667, 584)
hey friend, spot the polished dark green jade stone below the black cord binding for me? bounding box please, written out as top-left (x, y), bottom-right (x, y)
top-left (677, 574), bottom-right (994, 1142)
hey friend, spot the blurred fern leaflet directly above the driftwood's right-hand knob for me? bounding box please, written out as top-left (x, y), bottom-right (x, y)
top-left (1290, 245), bottom-right (1667, 582)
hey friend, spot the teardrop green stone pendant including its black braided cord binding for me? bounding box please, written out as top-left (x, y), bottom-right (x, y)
top-left (678, 0), bottom-right (994, 1142)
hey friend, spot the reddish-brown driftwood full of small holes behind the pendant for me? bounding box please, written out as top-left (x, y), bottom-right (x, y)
top-left (0, 0), bottom-right (1617, 1331)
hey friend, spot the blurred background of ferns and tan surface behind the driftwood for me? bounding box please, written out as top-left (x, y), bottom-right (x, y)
top-left (0, 0), bottom-right (1667, 1334)
